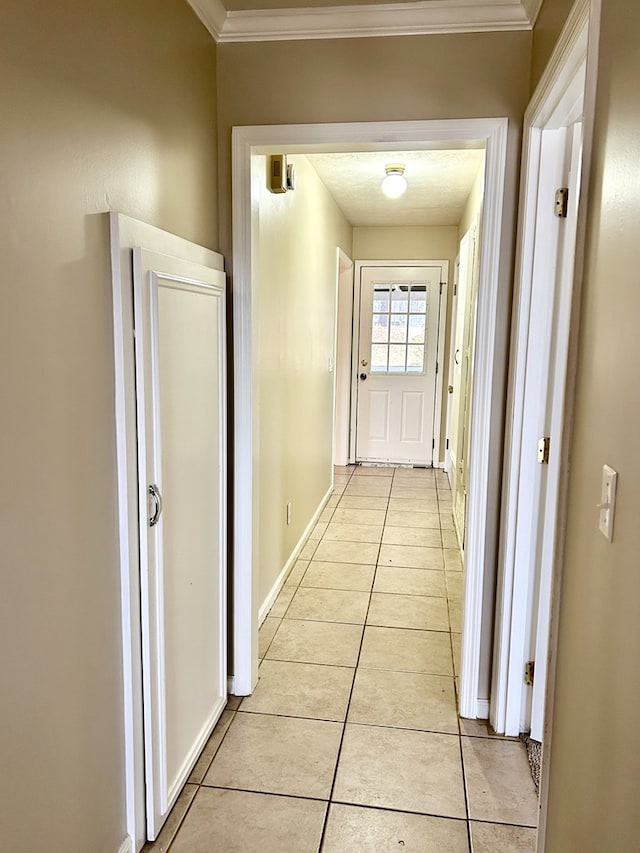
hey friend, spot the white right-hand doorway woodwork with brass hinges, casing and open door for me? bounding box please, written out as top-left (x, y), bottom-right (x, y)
top-left (491, 2), bottom-right (589, 740)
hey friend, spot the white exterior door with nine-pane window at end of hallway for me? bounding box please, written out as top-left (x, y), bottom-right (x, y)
top-left (354, 262), bottom-right (446, 465)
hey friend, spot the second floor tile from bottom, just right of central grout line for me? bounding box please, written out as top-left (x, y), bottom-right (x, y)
top-left (333, 723), bottom-right (466, 818)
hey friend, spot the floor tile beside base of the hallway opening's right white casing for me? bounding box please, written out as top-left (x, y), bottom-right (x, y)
top-left (347, 667), bottom-right (458, 734)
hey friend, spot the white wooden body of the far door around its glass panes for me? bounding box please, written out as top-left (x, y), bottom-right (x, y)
top-left (354, 264), bottom-right (445, 465)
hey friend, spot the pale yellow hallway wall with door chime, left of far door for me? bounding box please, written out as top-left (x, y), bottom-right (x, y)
top-left (252, 155), bottom-right (352, 606)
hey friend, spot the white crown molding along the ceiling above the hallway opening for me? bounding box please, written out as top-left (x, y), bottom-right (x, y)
top-left (189, 0), bottom-right (542, 43)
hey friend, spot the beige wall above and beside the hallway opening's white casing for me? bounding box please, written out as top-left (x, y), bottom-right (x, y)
top-left (218, 32), bottom-right (531, 708)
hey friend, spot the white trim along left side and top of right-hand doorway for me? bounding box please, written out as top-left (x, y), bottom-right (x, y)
top-left (491, 0), bottom-right (589, 735)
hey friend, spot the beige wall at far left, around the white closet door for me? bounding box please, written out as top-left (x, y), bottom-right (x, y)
top-left (0, 0), bottom-right (217, 853)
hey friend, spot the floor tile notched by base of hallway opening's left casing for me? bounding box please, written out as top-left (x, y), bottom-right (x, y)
top-left (240, 660), bottom-right (353, 721)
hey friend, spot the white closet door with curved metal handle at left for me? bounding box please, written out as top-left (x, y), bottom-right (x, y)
top-left (134, 249), bottom-right (226, 840)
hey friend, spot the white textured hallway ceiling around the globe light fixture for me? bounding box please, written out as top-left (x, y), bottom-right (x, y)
top-left (306, 149), bottom-right (484, 226)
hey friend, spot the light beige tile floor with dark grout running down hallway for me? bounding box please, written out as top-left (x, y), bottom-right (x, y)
top-left (145, 467), bottom-right (537, 853)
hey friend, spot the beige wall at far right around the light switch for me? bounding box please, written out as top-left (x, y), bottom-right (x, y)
top-left (545, 0), bottom-right (640, 853)
